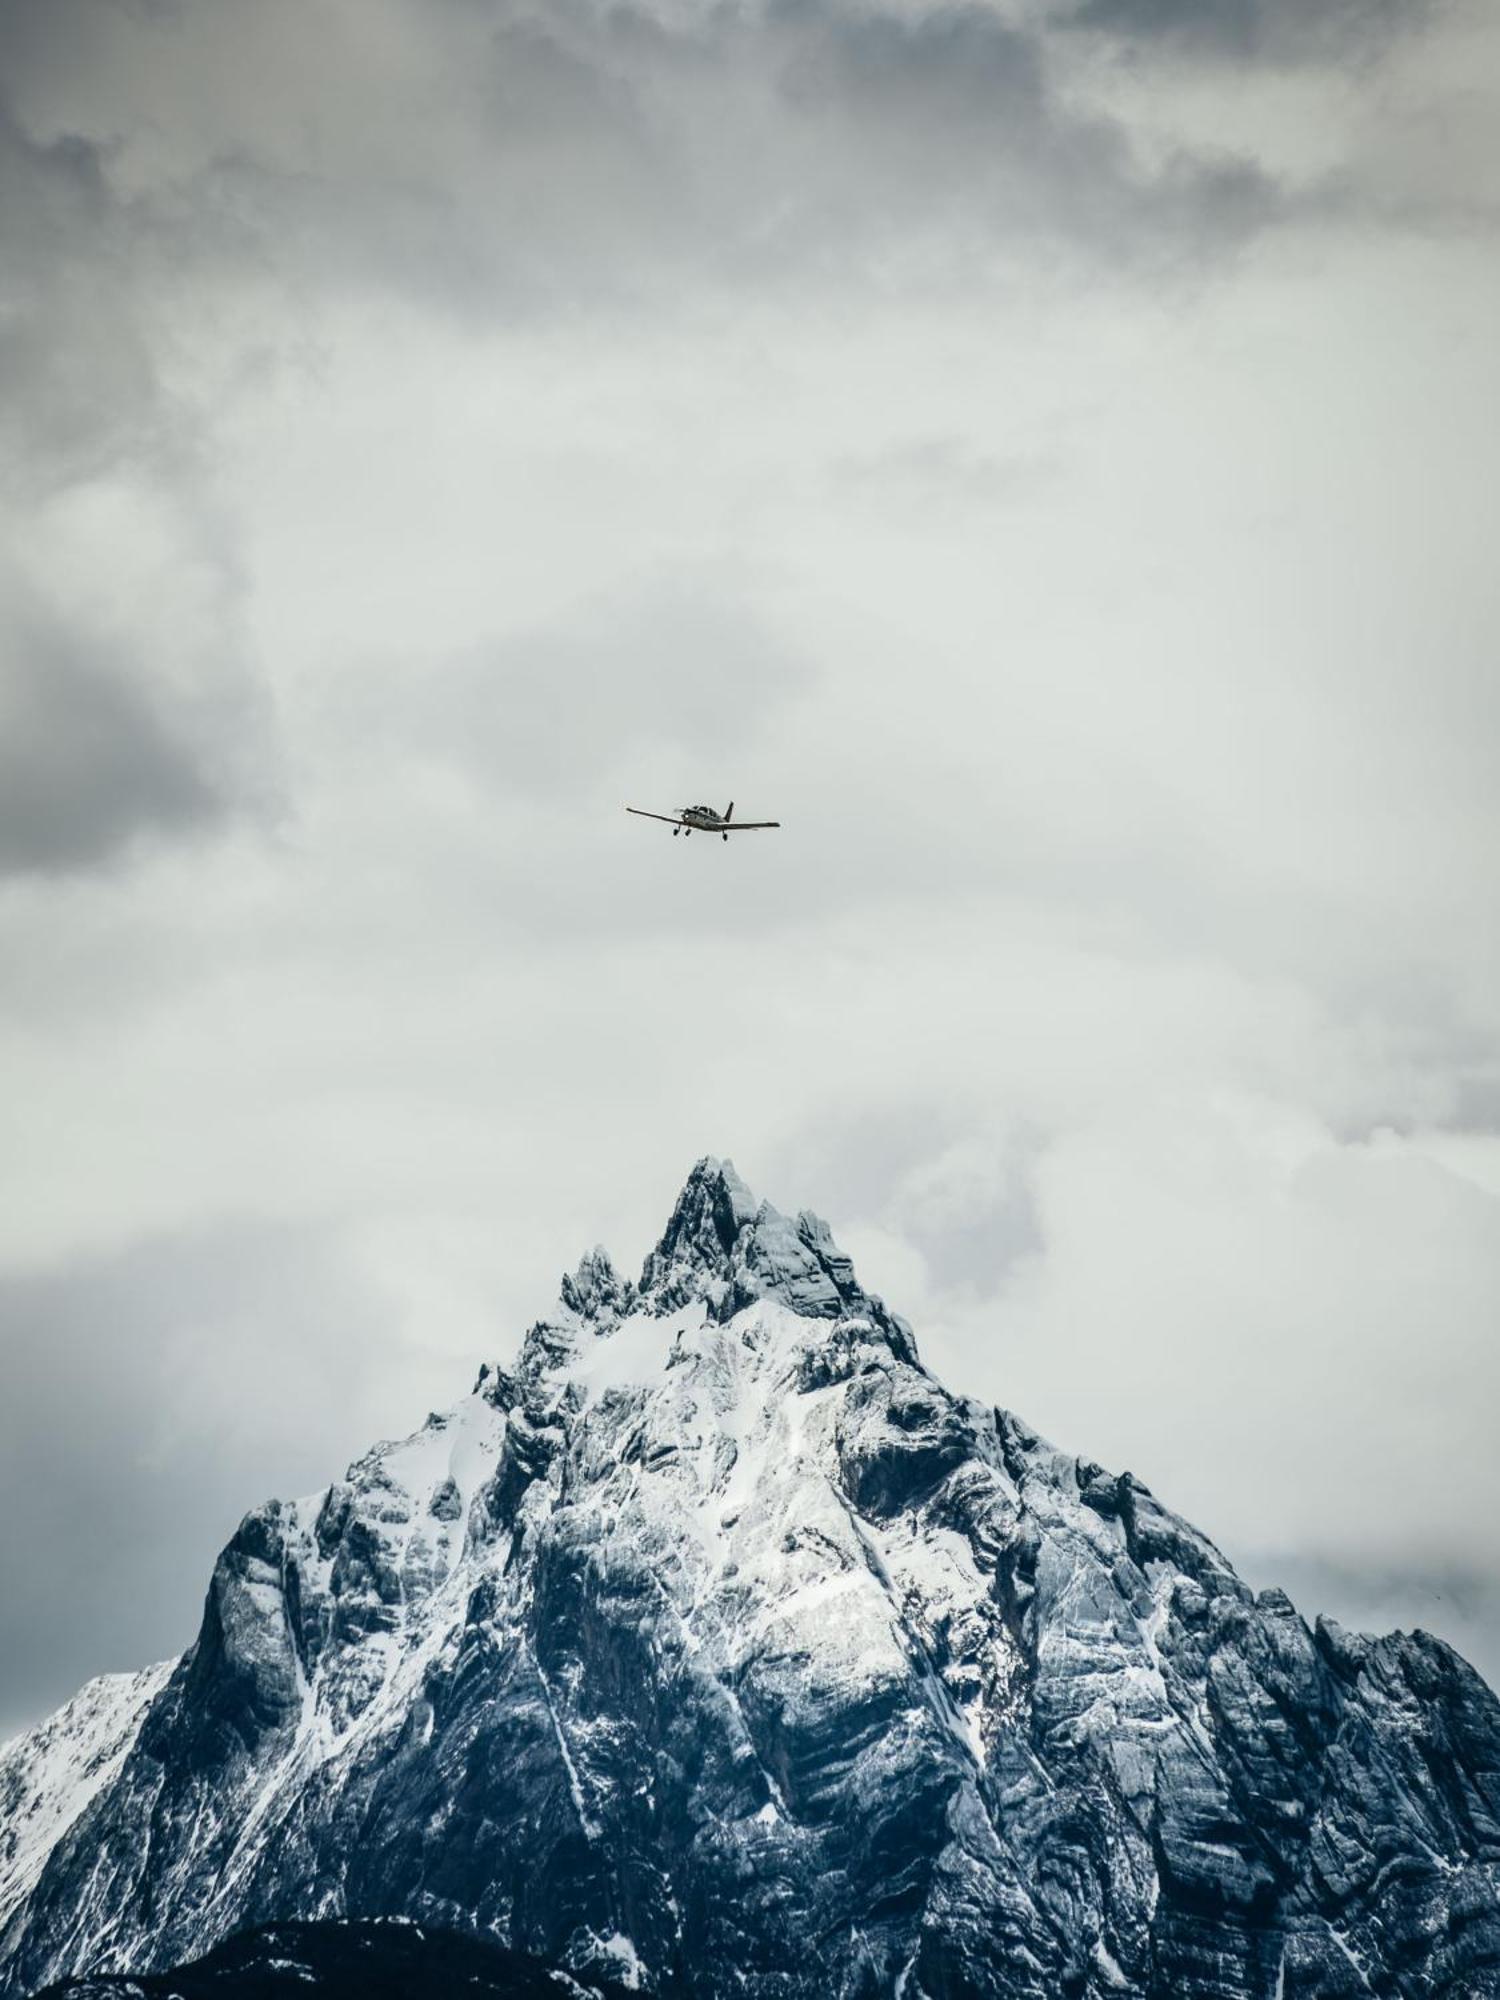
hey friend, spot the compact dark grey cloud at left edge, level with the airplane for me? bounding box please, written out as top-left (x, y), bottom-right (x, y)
top-left (0, 606), bottom-right (232, 874)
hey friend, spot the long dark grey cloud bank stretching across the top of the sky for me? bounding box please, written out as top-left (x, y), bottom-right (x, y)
top-left (6, 0), bottom-right (1286, 346)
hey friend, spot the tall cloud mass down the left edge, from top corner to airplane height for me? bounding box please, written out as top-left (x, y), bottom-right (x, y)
top-left (0, 76), bottom-right (276, 874)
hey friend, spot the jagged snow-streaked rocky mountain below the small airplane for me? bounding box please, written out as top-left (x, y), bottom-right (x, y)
top-left (0, 1160), bottom-right (1500, 2000)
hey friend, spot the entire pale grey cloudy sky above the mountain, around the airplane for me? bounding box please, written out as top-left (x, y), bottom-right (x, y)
top-left (0, 0), bottom-right (1500, 1726)
